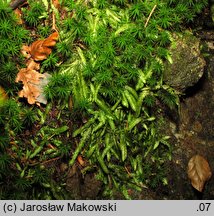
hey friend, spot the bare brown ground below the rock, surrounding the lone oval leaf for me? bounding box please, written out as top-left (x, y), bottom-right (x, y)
top-left (161, 38), bottom-right (214, 200)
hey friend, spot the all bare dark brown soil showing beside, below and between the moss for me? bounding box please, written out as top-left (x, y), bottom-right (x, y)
top-left (2, 0), bottom-right (214, 200)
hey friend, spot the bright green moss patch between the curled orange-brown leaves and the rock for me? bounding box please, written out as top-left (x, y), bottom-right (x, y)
top-left (51, 1), bottom-right (207, 198)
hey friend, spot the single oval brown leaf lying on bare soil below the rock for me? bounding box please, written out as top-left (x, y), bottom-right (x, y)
top-left (187, 155), bottom-right (212, 192)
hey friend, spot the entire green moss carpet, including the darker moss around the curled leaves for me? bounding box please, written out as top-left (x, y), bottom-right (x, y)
top-left (0, 0), bottom-right (207, 199)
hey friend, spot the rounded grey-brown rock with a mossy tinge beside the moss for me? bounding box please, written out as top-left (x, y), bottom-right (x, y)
top-left (164, 33), bottom-right (206, 92)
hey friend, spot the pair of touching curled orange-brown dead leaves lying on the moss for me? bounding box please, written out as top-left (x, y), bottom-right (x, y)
top-left (16, 32), bottom-right (59, 105)
